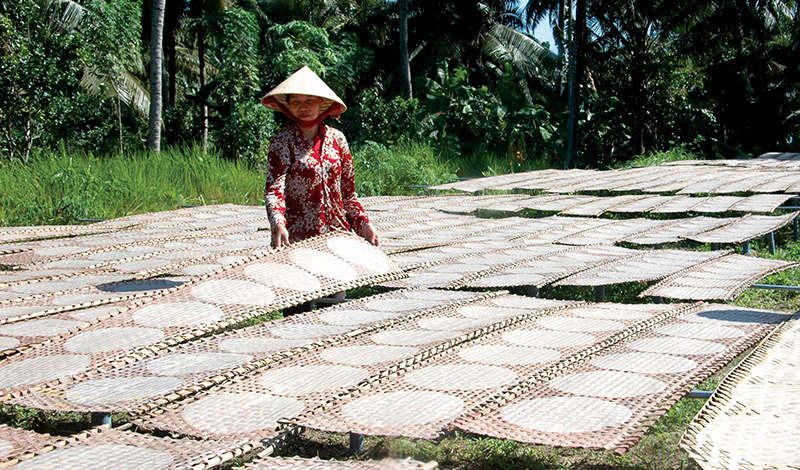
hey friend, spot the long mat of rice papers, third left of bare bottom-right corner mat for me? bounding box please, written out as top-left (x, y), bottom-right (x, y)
top-left (134, 295), bottom-right (580, 439)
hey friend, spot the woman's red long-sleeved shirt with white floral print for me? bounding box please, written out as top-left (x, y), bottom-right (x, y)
top-left (264, 121), bottom-right (369, 242)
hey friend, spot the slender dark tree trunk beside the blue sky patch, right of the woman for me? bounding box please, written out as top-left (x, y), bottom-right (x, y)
top-left (564, 0), bottom-right (586, 168)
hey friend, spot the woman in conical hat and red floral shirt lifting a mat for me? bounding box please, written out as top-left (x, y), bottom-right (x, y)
top-left (261, 66), bottom-right (379, 248)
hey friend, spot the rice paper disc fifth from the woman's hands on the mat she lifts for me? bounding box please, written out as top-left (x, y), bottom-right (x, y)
top-left (133, 302), bottom-right (225, 328)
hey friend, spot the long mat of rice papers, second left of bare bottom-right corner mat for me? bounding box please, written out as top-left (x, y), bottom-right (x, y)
top-left (295, 304), bottom-right (686, 439)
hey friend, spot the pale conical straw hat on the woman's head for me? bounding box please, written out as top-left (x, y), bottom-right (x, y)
top-left (261, 65), bottom-right (347, 117)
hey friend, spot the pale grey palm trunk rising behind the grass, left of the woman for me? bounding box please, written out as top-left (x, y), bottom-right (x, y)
top-left (147, 0), bottom-right (166, 153)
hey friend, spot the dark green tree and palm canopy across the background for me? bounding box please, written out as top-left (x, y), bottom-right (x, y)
top-left (0, 0), bottom-right (800, 168)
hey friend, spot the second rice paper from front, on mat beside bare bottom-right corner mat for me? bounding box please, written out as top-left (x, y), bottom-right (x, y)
top-left (550, 370), bottom-right (667, 398)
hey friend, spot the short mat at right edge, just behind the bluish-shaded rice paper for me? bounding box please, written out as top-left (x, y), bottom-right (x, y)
top-left (639, 255), bottom-right (800, 300)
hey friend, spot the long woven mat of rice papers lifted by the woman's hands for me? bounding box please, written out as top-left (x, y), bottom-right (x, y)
top-left (0, 233), bottom-right (403, 389)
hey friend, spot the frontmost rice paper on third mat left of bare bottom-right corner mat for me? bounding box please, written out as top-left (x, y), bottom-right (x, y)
top-left (181, 392), bottom-right (305, 435)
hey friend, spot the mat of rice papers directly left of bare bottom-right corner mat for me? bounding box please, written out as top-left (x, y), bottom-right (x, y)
top-left (455, 305), bottom-right (796, 453)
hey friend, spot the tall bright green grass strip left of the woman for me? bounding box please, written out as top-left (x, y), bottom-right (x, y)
top-left (0, 147), bottom-right (264, 226)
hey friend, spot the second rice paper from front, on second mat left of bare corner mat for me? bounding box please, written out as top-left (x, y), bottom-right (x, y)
top-left (403, 364), bottom-right (517, 391)
